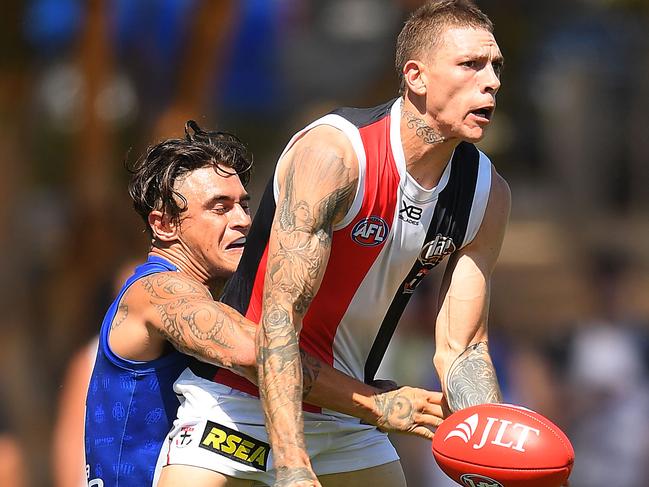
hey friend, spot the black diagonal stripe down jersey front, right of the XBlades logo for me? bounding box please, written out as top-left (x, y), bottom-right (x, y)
top-left (364, 142), bottom-right (480, 384)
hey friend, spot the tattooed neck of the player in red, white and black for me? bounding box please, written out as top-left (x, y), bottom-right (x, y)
top-left (401, 97), bottom-right (460, 189)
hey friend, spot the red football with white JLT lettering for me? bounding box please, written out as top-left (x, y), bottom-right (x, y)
top-left (433, 404), bottom-right (575, 487)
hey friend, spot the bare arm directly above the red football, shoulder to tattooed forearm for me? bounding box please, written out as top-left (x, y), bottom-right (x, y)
top-left (433, 170), bottom-right (511, 412)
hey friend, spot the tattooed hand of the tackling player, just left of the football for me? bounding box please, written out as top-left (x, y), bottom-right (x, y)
top-left (373, 386), bottom-right (444, 440)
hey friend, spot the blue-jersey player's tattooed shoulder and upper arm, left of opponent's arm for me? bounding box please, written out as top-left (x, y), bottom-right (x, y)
top-left (110, 272), bottom-right (256, 378)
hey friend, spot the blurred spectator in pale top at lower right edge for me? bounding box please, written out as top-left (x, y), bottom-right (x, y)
top-left (566, 250), bottom-right (649, 487)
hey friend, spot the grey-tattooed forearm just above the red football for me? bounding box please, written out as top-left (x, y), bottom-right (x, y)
top-left (446, 342), bottom-right (502, 412)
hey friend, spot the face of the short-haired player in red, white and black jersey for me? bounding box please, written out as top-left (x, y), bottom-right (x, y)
top-left (424, 27), bottom-right (503, 142)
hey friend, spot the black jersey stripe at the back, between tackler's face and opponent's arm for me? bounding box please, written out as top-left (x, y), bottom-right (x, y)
top-left (189, 177), bottom-right (275, 380)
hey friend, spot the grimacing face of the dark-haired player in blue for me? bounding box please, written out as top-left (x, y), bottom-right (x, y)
top-left (176, 167), bottom-right (250, 280)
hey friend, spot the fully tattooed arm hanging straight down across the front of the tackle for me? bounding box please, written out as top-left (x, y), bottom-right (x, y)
top-left (257, 126), bottom-right (358, 485)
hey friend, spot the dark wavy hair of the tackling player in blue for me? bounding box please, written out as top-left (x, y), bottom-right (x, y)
top-left (127, 120), bottom-right (252, 235)
